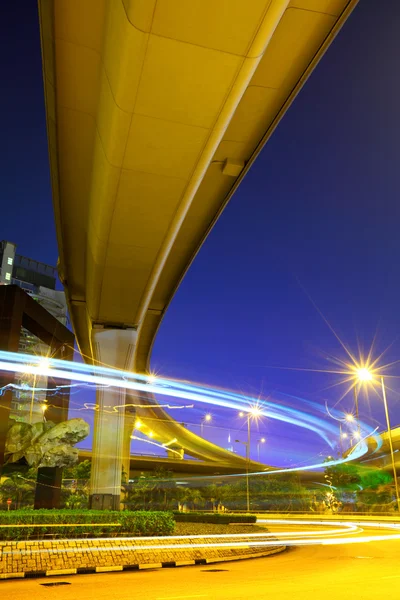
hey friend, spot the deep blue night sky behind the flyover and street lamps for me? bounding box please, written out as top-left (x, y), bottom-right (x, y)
top-left (0, 0), bottom-right (400, 464)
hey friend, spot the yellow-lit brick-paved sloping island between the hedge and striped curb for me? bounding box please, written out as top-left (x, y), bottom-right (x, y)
top-left (0, 534), bottom-right (285, 579)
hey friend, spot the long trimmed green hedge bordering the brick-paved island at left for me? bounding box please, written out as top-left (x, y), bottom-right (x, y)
top-left (0, 509), bottom-right (175, 540)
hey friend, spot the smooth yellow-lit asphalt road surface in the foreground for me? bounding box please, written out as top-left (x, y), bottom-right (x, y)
top-left (0, 530), bottom-right (400, 600)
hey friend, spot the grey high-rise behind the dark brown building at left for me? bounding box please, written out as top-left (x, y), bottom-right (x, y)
top-left (0, 240), bottom-right (68, 423)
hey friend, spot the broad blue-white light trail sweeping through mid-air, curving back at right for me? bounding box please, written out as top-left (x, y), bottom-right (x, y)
top-left (0, 351), bottom-right (376, 476)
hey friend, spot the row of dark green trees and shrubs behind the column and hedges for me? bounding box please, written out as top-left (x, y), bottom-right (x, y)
top-left (0, 460), bottom-right (396, 514)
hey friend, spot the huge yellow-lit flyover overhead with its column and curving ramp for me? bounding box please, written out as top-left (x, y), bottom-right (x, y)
top-left (39, 0), bottom-right (356, 507)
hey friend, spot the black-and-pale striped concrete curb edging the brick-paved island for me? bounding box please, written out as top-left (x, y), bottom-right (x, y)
top-left (0, 546), bottom-right (286, 581)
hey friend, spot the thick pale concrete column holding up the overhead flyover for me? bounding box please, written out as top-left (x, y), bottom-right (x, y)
top-left (89, 329), bottom-right (137, 510)
